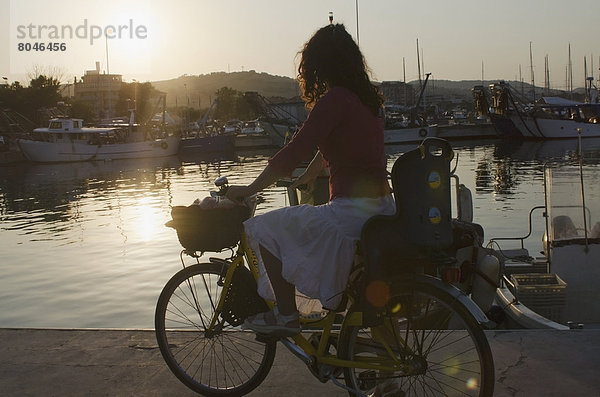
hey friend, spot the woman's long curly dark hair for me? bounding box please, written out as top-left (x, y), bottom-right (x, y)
top-left (298, 24), bottom-right (384, 115)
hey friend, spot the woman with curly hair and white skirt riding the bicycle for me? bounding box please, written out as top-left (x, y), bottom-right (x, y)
top-left (227, 24), bottom-right (395, 336)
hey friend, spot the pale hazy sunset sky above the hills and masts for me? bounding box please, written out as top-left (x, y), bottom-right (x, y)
top-left (0, 0), bottom-right (600, 89)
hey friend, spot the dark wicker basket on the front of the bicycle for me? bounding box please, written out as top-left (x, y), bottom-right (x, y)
top-left (166, 205), bottom-right (250, 252)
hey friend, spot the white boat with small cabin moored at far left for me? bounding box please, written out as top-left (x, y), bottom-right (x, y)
top-left (17, 117), bottom-right (180, 163)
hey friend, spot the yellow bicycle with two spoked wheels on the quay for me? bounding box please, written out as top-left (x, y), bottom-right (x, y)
top-left (155, 138), bottom-right (494, 396)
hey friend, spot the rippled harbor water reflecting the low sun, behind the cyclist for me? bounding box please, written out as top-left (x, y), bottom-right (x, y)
top-left (0, 139), bottom-right (600, 328)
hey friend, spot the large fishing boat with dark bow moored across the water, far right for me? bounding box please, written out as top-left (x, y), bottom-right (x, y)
top-left (490, 82), bottom-right (600, 139)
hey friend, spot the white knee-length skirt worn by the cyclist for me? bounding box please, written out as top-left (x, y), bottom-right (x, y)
top-left (244, 195), bottom-right (395, 309)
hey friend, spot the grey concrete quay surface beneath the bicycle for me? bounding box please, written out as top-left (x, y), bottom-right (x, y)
top-left (0, 328), bottom-right (600, 397)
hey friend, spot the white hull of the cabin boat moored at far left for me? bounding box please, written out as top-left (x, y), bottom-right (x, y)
top-left (18, 136), bottom-right (180, 163)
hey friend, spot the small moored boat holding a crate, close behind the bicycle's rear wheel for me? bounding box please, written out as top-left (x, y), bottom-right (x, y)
top-left (490, 152), bottom-right (600, 329)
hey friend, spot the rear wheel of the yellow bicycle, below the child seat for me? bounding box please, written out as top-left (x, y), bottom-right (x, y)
top-left (338, 281), bottom-right (494, 396)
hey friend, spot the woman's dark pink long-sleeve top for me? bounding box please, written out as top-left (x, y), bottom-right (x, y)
top-left (269, 87), bottom-right (390, 200)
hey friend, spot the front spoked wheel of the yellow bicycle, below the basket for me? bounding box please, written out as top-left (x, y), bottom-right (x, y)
top-left (154, 263), bottom-right (276, 396)
